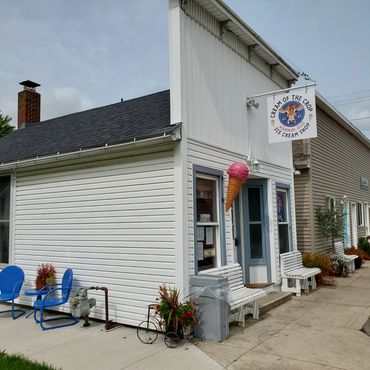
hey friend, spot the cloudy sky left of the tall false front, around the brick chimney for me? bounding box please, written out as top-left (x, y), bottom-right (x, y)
top-left (0, 0), bottom-right (169, 125)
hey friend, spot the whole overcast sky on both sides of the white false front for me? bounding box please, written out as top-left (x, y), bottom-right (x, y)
top-left (0, 0), bottom-right (370, 138)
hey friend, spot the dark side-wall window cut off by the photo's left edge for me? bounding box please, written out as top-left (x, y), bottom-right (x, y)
top-left (0, 177), bottom-right (10, 263)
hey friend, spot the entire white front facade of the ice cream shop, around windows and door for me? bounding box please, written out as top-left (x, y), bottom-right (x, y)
top-left (169, 0), bottom-right (296, 282)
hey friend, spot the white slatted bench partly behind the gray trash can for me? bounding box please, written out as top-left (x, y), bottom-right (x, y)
top-left (199, 263), bottom-right (267, 327)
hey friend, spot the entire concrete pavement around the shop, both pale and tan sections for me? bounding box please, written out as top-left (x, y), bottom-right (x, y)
top-left (0, 263), bottom-right (370, 370)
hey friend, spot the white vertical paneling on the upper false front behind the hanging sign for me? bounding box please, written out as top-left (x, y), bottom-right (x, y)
top-left (180, 9), bottom-right (291, 167)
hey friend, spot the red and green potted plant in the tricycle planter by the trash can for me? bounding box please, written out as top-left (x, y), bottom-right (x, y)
top-left (156, 285), bottom-right (197, 338)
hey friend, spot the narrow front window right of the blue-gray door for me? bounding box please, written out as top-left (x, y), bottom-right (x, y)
top-left (276, 188), bottom-right (290, 253)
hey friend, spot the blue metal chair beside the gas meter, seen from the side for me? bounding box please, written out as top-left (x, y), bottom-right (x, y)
top-left (33, 269), bottom-right (78, 330)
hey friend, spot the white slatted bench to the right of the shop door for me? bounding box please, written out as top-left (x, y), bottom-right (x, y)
top-left (280, 251), bottom-right (321, 297)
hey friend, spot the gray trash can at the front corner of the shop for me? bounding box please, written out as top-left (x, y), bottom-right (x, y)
top-left (190, 275), bottom-right (229, 342)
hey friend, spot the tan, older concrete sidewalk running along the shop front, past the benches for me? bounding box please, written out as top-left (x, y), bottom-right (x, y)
top-left (198, 262), bottom-right (370, 370)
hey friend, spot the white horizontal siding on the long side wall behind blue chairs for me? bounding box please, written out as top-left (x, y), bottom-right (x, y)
top-left (13, 151), bottom-right (175, 325)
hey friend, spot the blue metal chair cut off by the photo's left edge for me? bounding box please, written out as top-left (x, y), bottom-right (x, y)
top-left (0, 266), bottom-right (26, 320)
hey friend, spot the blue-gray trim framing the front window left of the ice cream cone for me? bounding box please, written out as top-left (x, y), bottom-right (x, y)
top-left (193, 165), bottom-right (227, 275)
